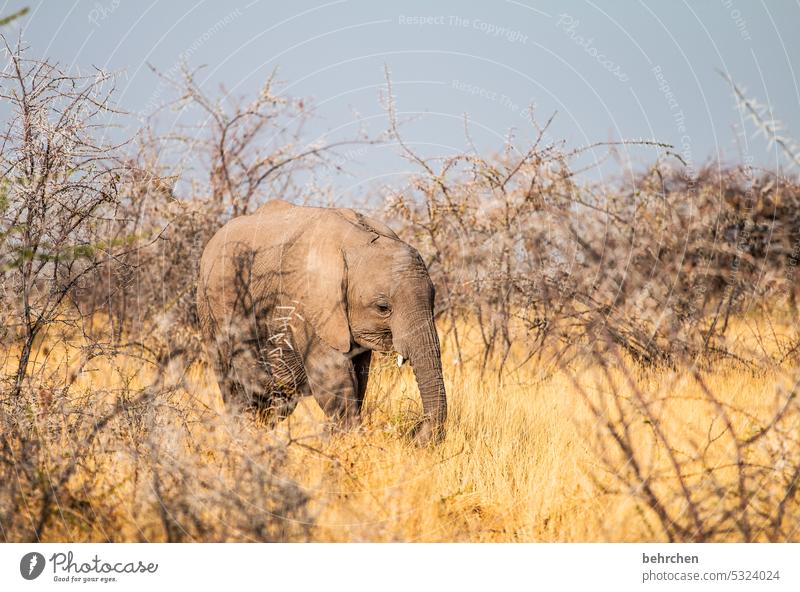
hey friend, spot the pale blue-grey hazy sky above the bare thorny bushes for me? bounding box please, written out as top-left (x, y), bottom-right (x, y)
top-left (0, 0), bottom-right (800, 201)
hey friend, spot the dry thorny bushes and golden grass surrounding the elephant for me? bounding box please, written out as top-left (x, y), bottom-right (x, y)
top-left (0, 41), bottom-right (800, 541)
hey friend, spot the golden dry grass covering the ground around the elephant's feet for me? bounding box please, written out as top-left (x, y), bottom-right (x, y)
top-left (14, 312), bottom-right (800, 542)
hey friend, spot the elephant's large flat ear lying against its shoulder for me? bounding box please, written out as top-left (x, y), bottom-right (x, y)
top-left (303, 241), bottom-right (350, 353)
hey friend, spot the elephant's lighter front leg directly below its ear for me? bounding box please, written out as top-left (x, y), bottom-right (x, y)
top-left (305, 340), bottom-right (361, 428)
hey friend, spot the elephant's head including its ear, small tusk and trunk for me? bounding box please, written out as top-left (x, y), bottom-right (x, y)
top-left (304, 210), bottom-right (447, 442)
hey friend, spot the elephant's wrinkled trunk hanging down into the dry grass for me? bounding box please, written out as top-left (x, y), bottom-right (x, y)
top-left (396, 311), bottom-right (447, 443)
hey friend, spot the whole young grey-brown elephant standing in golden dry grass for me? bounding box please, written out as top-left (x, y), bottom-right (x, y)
top-left (197, 200), bottom-right (447, 443)
